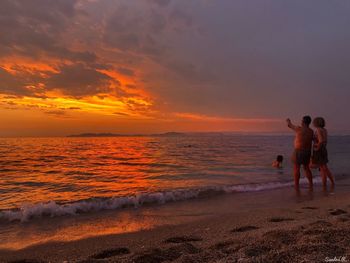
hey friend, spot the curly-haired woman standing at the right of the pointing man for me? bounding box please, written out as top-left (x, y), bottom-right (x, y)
top-left (311, 117), bottom-right (334, 189)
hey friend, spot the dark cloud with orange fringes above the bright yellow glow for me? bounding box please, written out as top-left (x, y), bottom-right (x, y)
top-left (0, 63), bottom-right (120, 98)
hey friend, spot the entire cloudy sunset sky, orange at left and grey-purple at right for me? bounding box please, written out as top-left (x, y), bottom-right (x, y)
top-left (0, 0), bottom-right (350, 137)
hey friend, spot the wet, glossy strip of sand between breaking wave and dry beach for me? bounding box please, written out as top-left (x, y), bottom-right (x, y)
top-left (0, 178), bottom-right (350, 252)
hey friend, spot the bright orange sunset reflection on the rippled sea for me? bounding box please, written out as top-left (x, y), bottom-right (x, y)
top-left (0, 137), bottom-right (205, 209)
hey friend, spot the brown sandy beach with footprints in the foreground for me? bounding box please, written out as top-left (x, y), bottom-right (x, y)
top-left (0, 181), bottom-right (350, 263)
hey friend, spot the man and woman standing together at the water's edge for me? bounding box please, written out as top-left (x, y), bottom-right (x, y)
top-left (287, 116), bottom-right (334, 190)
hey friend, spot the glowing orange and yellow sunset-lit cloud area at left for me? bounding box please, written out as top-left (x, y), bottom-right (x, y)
top-left (0, 56), bottom-right (154, 121)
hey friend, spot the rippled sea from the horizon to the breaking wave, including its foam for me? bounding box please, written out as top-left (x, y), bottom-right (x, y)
top-left (0, 134), bottom-right (350, 223)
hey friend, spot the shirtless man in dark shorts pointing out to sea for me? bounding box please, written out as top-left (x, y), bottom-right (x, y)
top-left (287, 116), bottom-right (314, 191)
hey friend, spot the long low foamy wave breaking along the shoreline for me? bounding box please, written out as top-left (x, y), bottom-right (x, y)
top-left (0, 178), bottom-right (321, 222)
